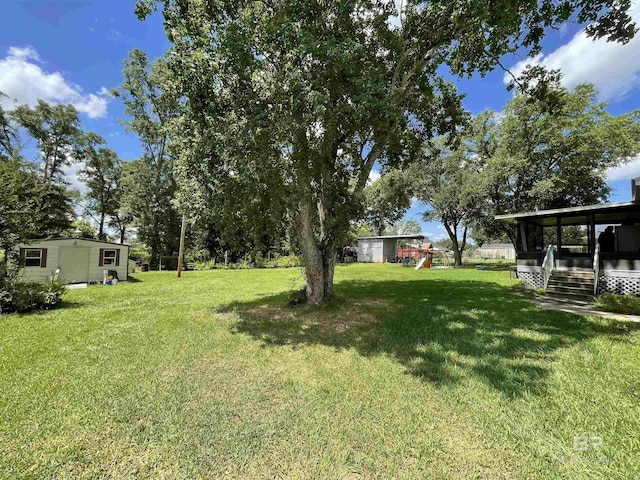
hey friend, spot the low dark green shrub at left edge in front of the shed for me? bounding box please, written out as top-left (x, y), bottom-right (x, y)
top-left (0, 278), bottom-right (66, 313)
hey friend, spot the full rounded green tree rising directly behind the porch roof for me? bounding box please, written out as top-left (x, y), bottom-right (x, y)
top-left (477, 82), bottom-right (640, 245)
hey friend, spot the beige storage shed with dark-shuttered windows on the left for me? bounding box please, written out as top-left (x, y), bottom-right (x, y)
top-left (19, 238), bottom-right (129, 283)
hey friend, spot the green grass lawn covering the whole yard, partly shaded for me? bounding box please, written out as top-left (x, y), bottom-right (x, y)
top-left (0, 265), bottom-right (640, 479)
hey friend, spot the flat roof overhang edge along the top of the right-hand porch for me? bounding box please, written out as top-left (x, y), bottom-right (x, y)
top-left (495, 202), bottom-right (640, 226)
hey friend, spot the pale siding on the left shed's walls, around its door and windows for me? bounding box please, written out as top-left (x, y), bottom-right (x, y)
top-left (19, 238), bottom-right (129, 282)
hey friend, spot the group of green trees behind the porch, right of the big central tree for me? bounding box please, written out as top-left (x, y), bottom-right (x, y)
top-left (364, 79), bottom-right (640, 265)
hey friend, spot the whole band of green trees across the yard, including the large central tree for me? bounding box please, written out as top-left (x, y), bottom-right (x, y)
top-left (0, 0), bottom-right (638, 303)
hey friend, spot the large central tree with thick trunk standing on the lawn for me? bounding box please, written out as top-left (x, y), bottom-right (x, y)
top-left (137, 0), bottom-right (635, 303)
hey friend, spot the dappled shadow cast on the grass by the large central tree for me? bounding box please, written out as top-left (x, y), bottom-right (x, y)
top-left (218, 279), bottom-right (638, 397)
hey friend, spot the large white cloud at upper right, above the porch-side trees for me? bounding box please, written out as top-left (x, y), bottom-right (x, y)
top-left (503, 1), bottom-right (640, 100)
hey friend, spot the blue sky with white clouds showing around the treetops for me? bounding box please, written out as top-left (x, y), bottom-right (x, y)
top-left (0, 0), bottom-right (640, 244)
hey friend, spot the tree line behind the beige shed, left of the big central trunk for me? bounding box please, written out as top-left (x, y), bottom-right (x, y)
top-left (0, 49), bottom-right (295, 274)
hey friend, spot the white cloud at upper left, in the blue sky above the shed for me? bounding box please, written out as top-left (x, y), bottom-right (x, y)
top-left (0, 47), bottom-right (108, 118)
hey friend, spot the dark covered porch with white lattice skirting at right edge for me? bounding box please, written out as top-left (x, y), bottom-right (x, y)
top-left (496, 180), bottom-right (640, 294)
